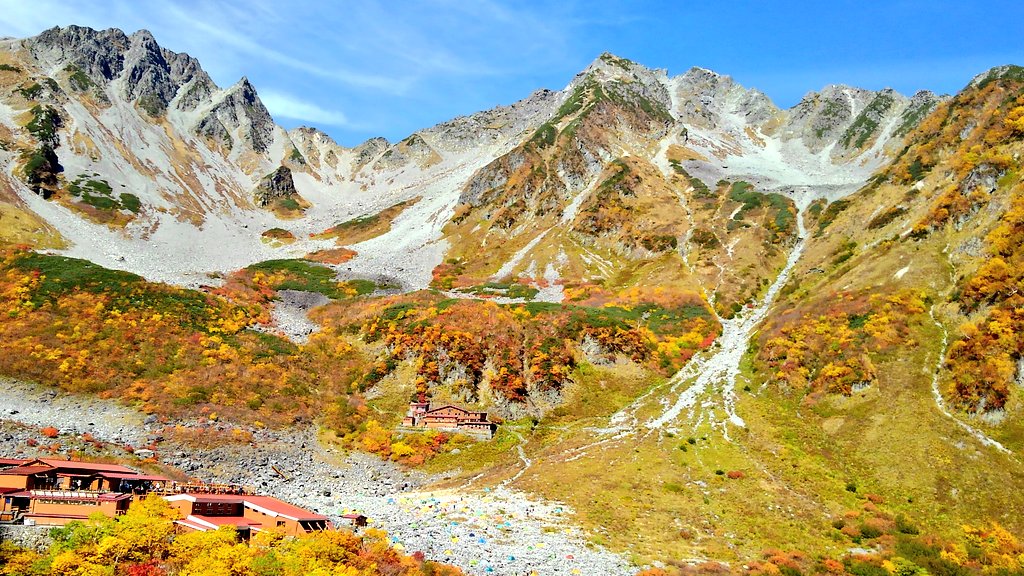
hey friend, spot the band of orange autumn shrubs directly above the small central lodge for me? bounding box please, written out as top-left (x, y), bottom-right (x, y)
top-left (314, 292), bottom-right (719, 402)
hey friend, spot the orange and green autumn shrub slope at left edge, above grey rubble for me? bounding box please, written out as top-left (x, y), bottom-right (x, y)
top-left (0, 243), bottom-right (361, 424)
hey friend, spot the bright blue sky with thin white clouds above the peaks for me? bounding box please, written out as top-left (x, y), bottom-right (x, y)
top-left (0, 0), bottom-right (1024, 146)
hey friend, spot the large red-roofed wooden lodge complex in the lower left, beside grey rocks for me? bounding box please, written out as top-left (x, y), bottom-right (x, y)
top-left (0, 458), bottom-right (348, 539)
